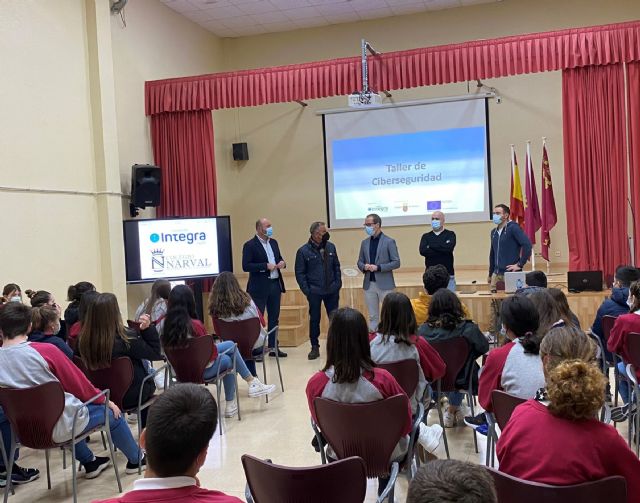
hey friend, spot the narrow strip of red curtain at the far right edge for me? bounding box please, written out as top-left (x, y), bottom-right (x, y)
top-left (627, 63), bottom-right (640, 266)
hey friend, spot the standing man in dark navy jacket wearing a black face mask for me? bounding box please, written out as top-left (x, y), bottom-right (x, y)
top-left (295, 222), bottom-right (342, 360)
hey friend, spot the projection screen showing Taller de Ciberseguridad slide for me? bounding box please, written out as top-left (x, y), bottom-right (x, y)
top-left (324, 99), bottom-right (491, 228)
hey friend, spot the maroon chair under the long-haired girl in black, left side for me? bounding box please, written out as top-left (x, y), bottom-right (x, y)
top-left (83, 356), bottom-right (167, 474)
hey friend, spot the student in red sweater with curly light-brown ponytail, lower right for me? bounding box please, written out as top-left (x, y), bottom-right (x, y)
top-left (496, 326), bottom-right (640, 503)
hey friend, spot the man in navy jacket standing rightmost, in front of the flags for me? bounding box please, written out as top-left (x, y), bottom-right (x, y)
top-left (488, 204), bottom-right (531, 290)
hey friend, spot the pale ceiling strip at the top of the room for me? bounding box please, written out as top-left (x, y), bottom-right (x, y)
top-left (161, 0), bottom-right (501, 37)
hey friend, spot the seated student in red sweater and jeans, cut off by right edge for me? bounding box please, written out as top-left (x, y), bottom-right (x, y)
top-left (607, 281), bottom-right (640, 422)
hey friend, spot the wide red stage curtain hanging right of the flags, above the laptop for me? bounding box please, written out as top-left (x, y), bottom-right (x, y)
top-left (562, 64), bottom-right (629, 279)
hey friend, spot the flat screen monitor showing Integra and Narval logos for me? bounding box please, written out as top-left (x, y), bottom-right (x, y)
top-left (124, 216), bottom-right (233, 283)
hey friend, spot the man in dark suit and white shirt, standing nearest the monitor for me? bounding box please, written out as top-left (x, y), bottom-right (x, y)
top-left (242, 218), bottom-right (287, 357)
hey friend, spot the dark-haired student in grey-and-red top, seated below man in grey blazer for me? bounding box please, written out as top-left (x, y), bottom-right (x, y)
top-left (370, 292), bottom-right (446, 453)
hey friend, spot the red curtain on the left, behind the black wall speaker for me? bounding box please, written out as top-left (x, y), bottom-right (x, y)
top-left (151, 110), bottom-right (217, 217)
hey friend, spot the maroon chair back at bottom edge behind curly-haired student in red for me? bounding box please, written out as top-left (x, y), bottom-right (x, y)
top-left (487, 468), bottom-right (627, 503)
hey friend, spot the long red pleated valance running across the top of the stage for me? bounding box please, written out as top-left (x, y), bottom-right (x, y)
top-left (145, 21), bottom-right (640, 115)
